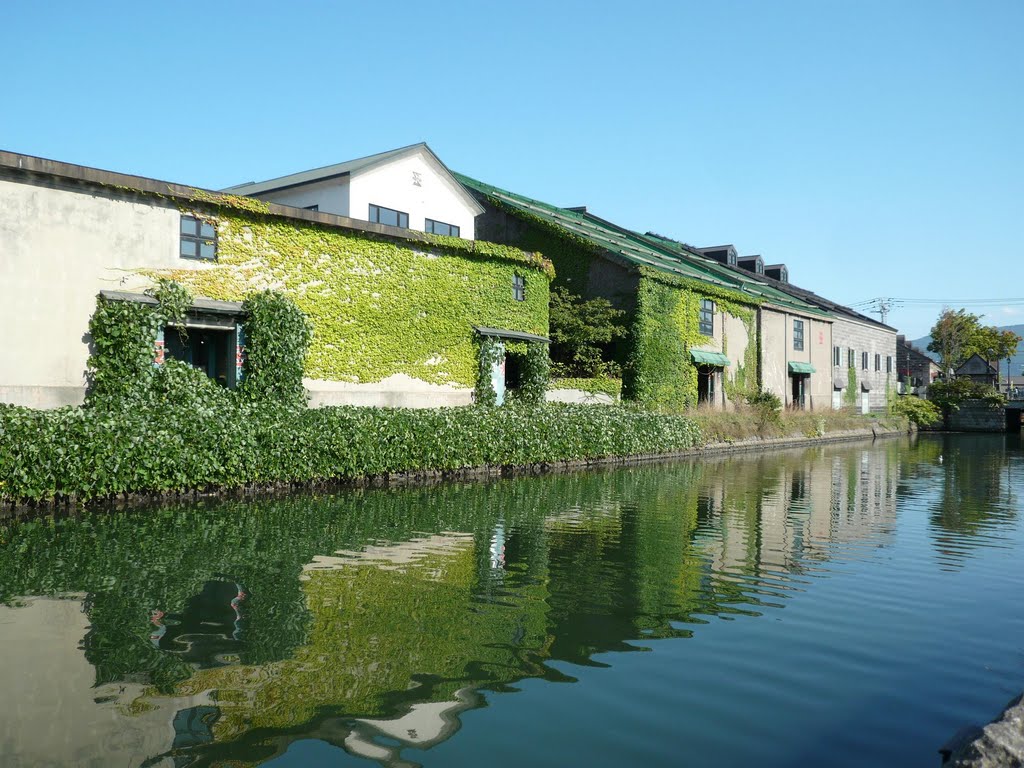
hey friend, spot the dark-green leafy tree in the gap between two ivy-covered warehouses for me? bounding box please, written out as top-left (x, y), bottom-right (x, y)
top-left (550, 287), bottom-right (626, 378)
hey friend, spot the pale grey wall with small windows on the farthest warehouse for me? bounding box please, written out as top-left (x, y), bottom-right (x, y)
top-left (828, 316), bottom-right (898, 412)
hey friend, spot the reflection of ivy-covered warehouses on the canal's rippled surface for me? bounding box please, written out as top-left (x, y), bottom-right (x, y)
top-left (0, 439), bottom-right (1019, 767)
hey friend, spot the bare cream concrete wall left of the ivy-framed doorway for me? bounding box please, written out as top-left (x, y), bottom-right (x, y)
top-left (0, 179), bottom-right (182, 408)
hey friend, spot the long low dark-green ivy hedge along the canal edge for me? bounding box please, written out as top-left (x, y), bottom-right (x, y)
top-left (0, 397), bottom-right (700, 502)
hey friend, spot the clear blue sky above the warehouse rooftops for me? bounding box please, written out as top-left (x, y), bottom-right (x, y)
top-left (0, 0), bottom-right (1024, 338)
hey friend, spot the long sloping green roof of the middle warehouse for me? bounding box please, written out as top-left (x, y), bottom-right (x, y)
top-left (453, 173), bottom-right (829, 317)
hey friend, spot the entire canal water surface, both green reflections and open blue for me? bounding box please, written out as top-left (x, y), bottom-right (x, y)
top-left (0, 435), bottom-right (1024, 768)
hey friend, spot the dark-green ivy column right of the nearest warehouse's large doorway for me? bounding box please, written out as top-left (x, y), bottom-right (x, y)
top-left (241, 291), bottom-right (312, 408)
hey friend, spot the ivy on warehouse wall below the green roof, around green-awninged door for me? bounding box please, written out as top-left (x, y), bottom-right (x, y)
top-left (623, 271), bottom-right (758, 409)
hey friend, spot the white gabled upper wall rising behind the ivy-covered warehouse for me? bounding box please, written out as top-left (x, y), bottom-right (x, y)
top-left (348, 150), bottom-right (478, 240)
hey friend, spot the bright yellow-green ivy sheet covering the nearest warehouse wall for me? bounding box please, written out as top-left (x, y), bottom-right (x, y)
top-left (150, 207), bottom-right (553, 387)
